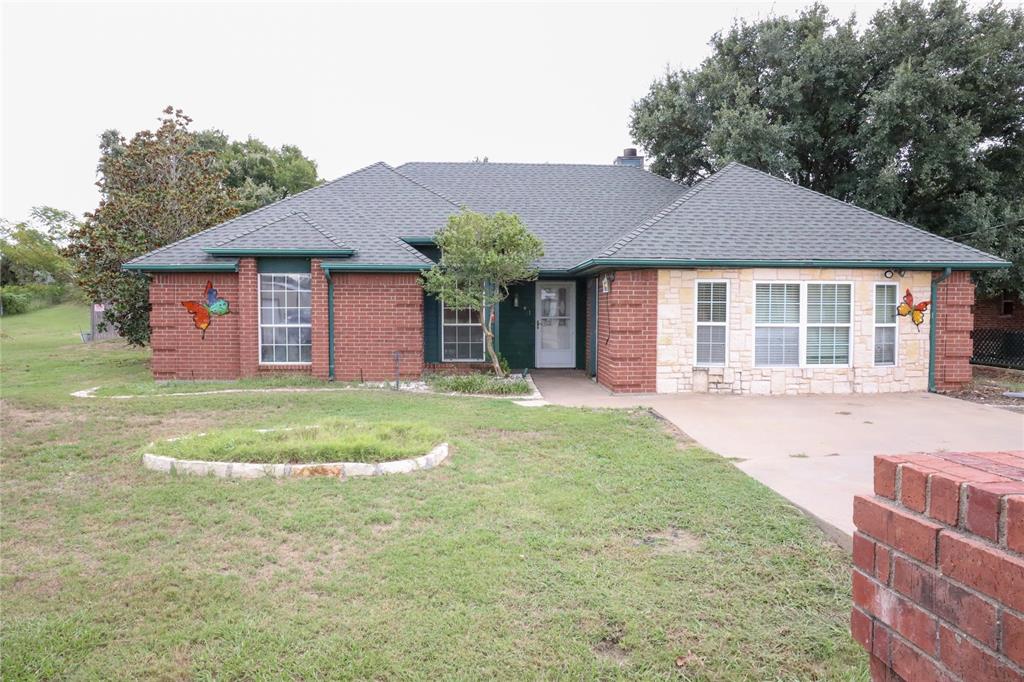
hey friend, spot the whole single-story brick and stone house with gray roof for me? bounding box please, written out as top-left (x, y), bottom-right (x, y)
top-left (125, 151), bottom-right (1008, 394)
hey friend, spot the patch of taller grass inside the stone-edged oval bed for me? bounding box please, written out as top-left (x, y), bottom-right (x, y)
top-left (144, 419), bottom-right (444, 464)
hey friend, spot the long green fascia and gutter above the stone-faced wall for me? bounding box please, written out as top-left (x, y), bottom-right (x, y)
top-left (568, 258), bottom-right (1011, 274)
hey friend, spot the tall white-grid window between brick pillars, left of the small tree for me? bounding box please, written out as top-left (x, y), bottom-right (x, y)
top-left (259, 272), bottom-right (312, 365)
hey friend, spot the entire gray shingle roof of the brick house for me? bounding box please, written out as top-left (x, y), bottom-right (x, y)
top-left (126, 163), bottom-right (1002, 270)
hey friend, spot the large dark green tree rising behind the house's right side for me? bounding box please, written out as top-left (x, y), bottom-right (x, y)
top-left (631, 0), bottom-right (1024, 296)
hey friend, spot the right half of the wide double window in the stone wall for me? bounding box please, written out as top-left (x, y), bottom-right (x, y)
top-left (805, 284), bottom-right (853, 365)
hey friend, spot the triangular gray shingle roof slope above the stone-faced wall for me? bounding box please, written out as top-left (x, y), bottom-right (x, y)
top-left (598, 163), bottom-right (1002, 264)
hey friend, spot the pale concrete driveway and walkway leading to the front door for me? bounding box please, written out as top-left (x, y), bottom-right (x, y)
top-left (532, 370), bottom-right (1024, 541)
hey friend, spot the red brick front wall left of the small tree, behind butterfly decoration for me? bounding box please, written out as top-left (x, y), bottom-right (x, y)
top-left (150, 266), bottom-right (423, 381)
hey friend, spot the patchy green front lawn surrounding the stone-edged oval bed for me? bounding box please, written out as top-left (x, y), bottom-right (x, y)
top-left (0, 306), bottom-right (867, 680)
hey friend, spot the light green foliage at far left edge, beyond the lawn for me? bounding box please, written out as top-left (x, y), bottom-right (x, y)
top-left (0, 206), bottom-right (79, 285)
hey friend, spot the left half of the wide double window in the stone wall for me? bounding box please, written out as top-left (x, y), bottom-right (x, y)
top-left (754, 282), bottom-right (800, 367)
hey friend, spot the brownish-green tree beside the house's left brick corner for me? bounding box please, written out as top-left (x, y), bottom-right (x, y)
top-left (66, 106), bottom-right (238, 345)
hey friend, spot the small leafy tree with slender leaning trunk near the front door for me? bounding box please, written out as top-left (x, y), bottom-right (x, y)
top-left (423, 210), bottom-right (544, 377)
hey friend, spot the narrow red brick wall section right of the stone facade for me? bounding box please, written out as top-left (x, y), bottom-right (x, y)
top-left (932, 271), bottom-right (974, 391)
